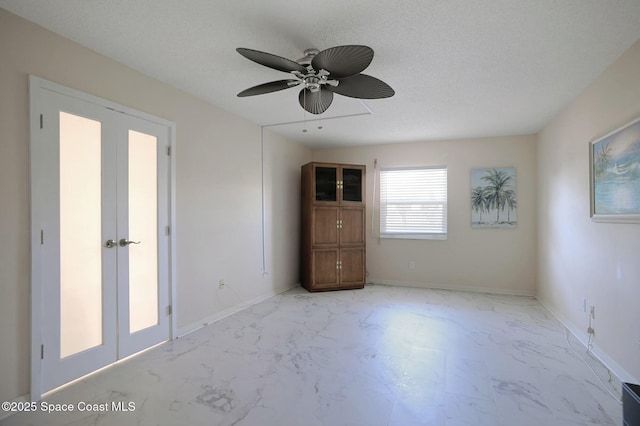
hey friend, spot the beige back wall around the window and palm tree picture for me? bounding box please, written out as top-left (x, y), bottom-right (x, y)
top-left (313, 136), bottom-right (536, 295)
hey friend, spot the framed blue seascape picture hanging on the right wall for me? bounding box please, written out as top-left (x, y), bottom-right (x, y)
top-left (589, 117), bottom-right (640, 223)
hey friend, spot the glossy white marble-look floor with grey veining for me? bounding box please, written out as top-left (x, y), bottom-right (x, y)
top-left (0, 285), bottom-right (622, 426)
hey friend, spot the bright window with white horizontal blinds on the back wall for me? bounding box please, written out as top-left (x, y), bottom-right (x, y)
top-left (380, 167), bottom-right (447, 240)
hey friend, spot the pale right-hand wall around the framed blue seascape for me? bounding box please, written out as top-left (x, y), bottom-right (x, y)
top-left (538, 38), bottom-right (640, 383)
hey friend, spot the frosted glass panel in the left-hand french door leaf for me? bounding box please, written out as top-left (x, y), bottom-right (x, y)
top-left (60, 112), bottom-right (102, 358)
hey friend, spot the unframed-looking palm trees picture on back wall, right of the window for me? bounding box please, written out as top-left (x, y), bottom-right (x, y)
top-left (471, 167), bottom-right (518, 229)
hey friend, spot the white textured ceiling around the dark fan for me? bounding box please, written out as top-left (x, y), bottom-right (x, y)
top-left (0, 0), bottom-right (640, 147)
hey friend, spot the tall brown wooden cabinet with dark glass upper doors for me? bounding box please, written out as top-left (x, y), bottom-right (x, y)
top-left (302, 163), bottom-right (366, 291)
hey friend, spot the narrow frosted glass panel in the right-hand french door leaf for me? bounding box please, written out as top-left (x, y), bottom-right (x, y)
top-left (128, 130), bottom-right (158, 333)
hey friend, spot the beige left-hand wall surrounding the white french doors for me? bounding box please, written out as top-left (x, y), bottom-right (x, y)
top-left (0, 9), bottom-right (311, 401)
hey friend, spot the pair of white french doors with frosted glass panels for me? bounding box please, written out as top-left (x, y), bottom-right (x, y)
top-left (32, 80), bottom-right (171, 393)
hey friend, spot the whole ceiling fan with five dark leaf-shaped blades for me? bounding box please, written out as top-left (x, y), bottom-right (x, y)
top-left (236, 45), bottom-right (395, 114)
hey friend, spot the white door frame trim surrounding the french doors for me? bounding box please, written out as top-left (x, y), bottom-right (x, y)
top-left (29, 75), bottom-right (178, 402)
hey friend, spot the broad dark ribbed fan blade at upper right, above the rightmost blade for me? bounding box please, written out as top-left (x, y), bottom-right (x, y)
top-left (311, 45), bottom-right (373, 78)
